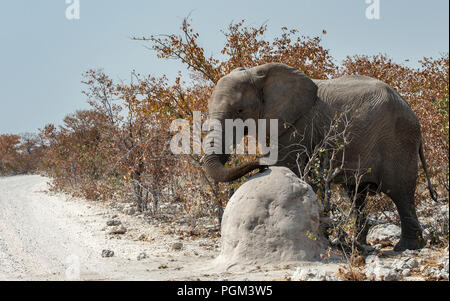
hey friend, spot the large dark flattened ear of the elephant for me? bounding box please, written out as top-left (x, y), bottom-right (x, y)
top-left (252, 63), bottom-right (317, 124)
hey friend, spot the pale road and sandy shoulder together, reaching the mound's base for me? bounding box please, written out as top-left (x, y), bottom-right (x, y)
top-left (0, 176), bottom-right (337, 280)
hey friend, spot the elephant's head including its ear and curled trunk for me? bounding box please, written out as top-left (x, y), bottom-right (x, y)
top-left (204, 63), bottom-right (317, 182)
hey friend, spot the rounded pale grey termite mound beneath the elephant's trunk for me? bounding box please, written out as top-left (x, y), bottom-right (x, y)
top-left (216, 167), bottom-right (324, 266)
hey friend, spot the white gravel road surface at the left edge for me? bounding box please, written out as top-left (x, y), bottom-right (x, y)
top-left (0, 176), bottom-right (130, 280)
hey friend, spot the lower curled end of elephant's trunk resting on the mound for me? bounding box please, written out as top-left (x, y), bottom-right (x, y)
top-left (204, 154), bottom-right (262, 182)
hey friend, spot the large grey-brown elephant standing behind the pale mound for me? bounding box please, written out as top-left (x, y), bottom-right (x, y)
top-left (204, 63), bottom-right (436, 251)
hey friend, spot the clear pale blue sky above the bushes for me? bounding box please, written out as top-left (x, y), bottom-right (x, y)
top-left (0, 0), bottom-right (449, 134)
